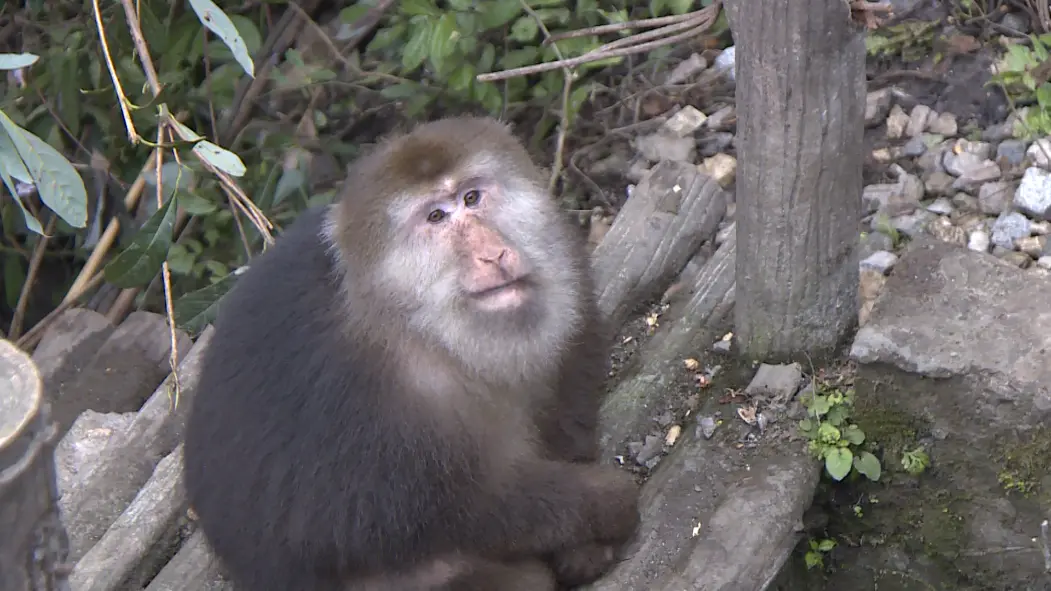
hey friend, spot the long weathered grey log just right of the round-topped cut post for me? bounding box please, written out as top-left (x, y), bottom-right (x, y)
top-left (61, 327), bottom-right (212, 561)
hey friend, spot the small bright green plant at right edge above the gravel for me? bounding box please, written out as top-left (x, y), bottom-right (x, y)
top-left (988, 34), bottom-right (1051, 138)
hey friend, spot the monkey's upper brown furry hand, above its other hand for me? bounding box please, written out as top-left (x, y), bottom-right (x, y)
top-left (588, 465), bottom-right (639, 546)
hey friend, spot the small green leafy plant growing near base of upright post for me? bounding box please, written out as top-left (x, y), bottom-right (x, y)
top-left (799, 384), bottom-right (882, 482)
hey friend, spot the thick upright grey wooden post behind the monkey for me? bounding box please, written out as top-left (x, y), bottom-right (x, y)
top-left (726, 0), bottom-right (865, 362)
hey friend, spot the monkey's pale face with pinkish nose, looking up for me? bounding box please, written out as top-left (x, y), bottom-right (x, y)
top-left (383, 177), bottom-right (557, 323)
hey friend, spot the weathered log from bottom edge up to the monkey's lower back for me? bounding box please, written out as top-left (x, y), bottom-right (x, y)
top-left (69, 444), bottom-right (189, 591)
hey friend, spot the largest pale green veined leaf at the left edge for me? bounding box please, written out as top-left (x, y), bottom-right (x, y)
top-left (0, 110), bottom-right (87, 228)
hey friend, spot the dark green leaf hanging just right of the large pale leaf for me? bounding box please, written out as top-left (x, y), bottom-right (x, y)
top-left (103, 195), bottom-right (179, 289)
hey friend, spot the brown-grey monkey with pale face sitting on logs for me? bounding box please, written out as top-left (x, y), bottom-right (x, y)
top-left (184, 116), bottom-right (640, 591)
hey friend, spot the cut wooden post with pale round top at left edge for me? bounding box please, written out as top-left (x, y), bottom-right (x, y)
top-left (0, 339), bottom-right (68, 591)
